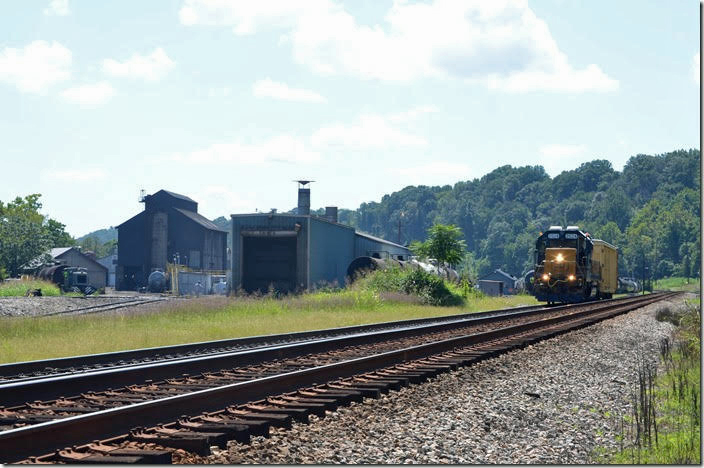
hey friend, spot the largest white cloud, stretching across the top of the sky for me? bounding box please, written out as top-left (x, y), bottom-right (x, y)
top-left (179, 0), bottom-right (618, 92)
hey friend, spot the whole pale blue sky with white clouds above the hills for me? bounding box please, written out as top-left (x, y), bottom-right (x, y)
top-left (0, 0), bottom-right (701, 236)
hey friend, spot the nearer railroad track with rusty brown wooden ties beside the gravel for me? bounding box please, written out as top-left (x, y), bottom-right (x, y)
top-left (0, 295), bottom-right (669, 463)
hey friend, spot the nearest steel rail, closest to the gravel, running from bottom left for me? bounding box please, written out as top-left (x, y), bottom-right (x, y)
top-left (0, 295), bottom-right (668, 462)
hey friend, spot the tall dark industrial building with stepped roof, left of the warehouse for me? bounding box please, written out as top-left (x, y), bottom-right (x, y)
top-left (115, 190), bottom-right (227, 290)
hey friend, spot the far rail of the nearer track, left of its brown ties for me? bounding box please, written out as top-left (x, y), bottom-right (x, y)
top-left (0, 296), bottom-right (660, 407)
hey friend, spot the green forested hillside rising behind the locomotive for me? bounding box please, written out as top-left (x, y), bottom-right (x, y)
top-left (340, 150), bottom-right (701, 277)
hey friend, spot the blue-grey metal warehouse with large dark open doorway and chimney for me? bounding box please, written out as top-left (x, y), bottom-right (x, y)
top-left (231, 181), bottom-right (411, 292)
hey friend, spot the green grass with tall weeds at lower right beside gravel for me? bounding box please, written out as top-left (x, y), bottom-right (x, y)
top-left (602, 301), bottom-right (701, 465)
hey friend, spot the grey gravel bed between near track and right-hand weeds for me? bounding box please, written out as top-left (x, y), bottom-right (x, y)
top-left (182, 299), bottom-right (682, 464)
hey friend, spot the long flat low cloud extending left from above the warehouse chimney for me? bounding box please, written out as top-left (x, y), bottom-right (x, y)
top-left (168, 135), bottom-right (320, 165)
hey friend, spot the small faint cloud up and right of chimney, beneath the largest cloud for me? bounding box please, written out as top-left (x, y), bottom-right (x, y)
top-left (311, 115), bottom-right (428, 148)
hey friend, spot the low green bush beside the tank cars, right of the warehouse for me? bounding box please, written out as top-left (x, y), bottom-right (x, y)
top-left (360, 268), bottom-right (464, 306)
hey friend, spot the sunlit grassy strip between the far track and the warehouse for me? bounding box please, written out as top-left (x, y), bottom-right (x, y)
top-left (0, 289), bottom-right (537, 363)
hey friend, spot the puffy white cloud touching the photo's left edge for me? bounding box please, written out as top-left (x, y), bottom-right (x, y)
top-left (0, 41), bottom-right (71, 93)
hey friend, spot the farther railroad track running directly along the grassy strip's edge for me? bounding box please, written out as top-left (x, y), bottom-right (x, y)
top-left (0, 301), bottom-right (640, 384)
